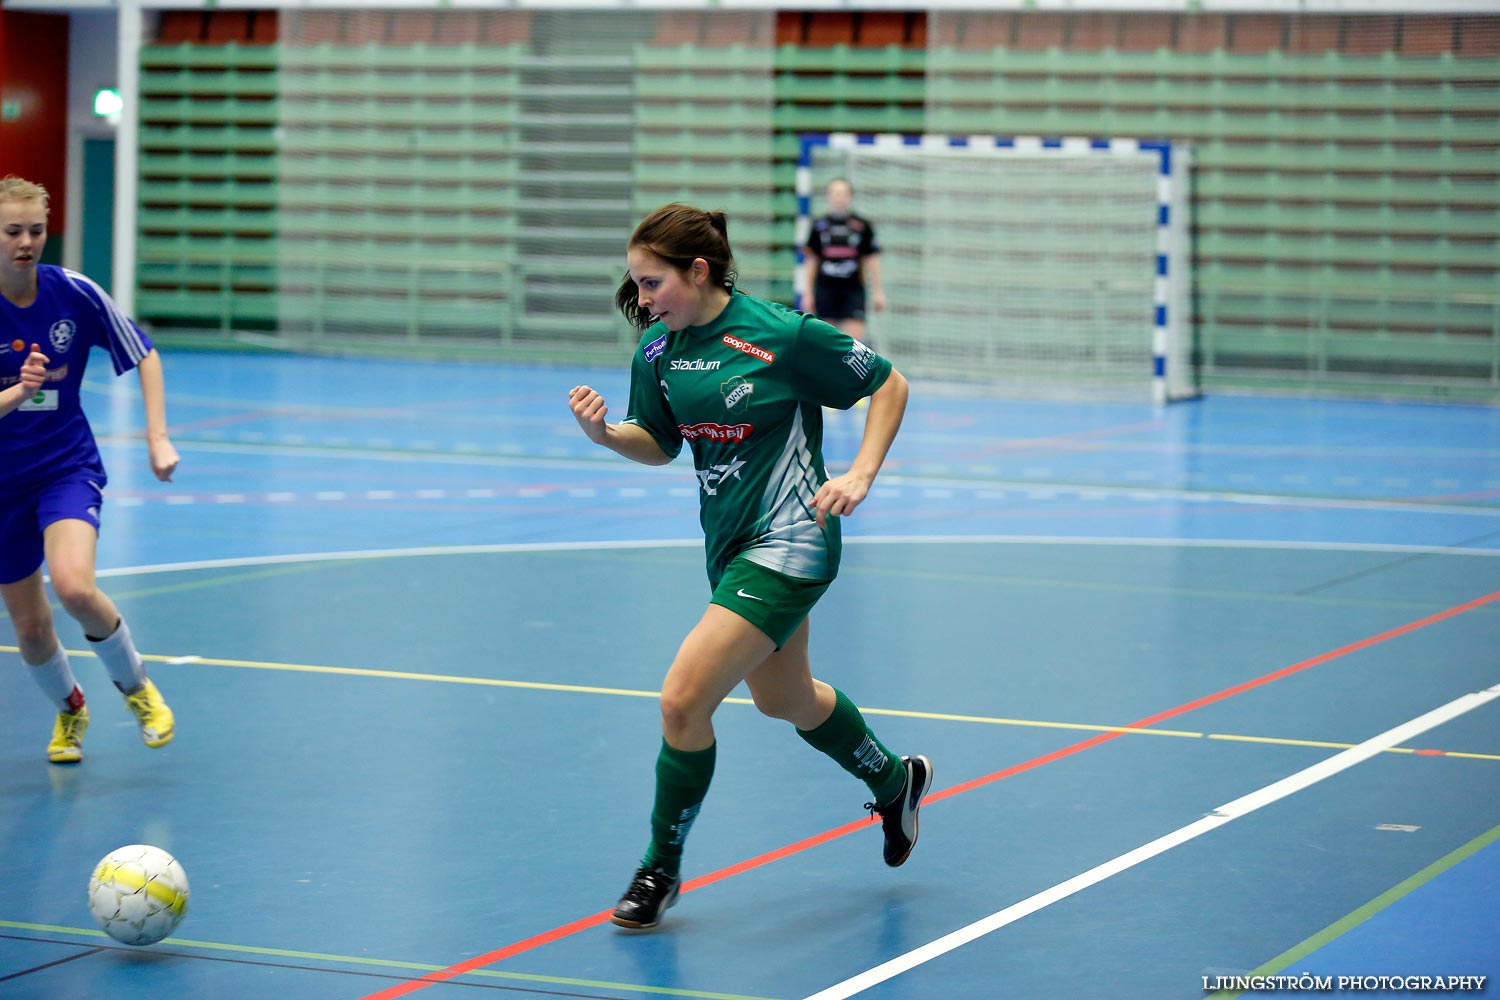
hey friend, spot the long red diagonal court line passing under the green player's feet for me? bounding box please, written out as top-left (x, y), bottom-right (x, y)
top-left (362, 591), bottom-right (1500, 1000)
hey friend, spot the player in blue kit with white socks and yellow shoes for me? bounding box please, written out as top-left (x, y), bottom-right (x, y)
top-left (0, 177), bottom-right (177, 763)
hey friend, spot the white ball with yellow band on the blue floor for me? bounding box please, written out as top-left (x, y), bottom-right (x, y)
top-left (89, 844), bottom-right (188, 945)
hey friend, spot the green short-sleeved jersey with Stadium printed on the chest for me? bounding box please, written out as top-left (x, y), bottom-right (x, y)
top-left (626, 291), bottom-right (891, 585)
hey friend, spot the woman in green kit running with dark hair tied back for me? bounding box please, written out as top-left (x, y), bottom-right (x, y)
top-left (569, 204), bottom-right (933, 928)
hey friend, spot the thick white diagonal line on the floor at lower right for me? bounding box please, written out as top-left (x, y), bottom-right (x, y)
top-left (807, 684), bottom-right (1500, 1000)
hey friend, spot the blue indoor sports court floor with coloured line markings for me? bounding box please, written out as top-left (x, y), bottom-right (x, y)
top-left (0, 352), bottom-right (1500, 1000)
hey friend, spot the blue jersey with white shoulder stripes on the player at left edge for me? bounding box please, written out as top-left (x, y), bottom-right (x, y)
top-left (0, 264), bottom-right (152, 495)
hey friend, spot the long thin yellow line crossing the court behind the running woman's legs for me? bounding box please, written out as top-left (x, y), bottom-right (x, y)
top-left (0, 646), bottom-right (1500, 760)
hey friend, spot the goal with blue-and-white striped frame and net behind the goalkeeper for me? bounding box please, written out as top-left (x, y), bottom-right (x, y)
top-left (794, 132), bottom-right (1197, 402)
